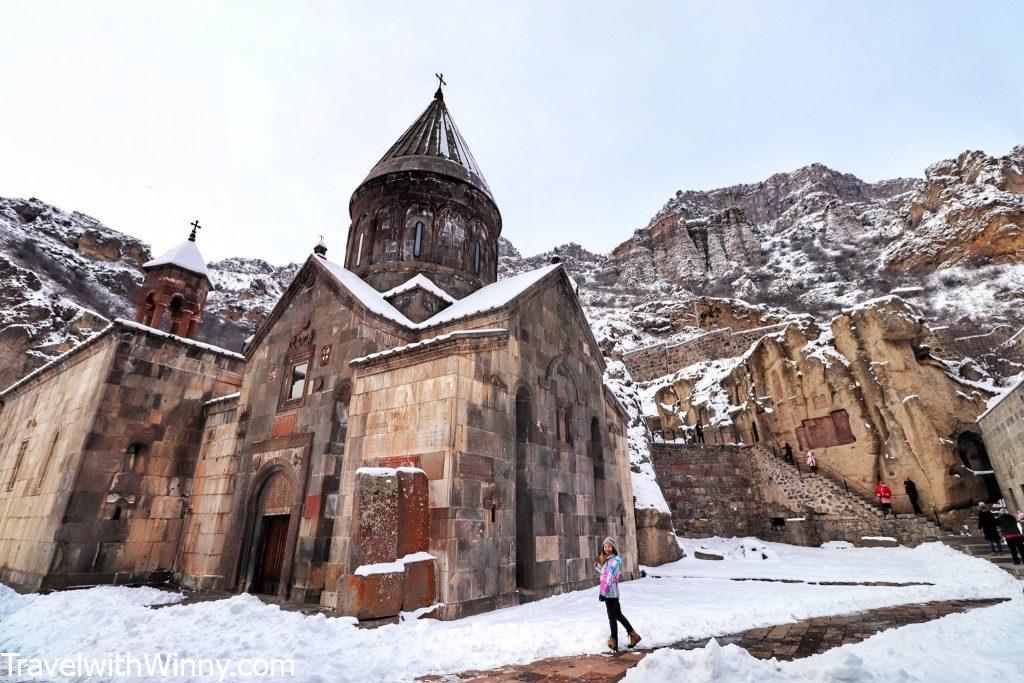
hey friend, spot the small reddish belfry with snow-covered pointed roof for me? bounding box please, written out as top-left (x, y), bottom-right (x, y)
top-left (135, 221), bottom-right (213, 339)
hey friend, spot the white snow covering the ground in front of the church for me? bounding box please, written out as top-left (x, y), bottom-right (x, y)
top-left (0, 539), bottom-right (1024, 681)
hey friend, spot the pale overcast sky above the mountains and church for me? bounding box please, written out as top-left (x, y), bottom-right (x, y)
top-left (0, 0), bottom-right (1024, 263)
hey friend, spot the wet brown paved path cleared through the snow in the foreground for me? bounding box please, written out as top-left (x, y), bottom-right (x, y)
top-left (436, 598), bottom-right (1006, 683)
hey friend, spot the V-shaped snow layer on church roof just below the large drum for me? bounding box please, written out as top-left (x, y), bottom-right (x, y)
top-left (316, 255), bottom-right (561, 330)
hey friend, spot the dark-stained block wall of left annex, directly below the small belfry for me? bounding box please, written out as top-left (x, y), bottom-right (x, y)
top-left (43, 327), bottom-right (242, 588)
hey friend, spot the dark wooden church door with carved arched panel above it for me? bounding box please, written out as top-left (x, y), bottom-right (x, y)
top-left (250, 470), bottom-right (295, 595)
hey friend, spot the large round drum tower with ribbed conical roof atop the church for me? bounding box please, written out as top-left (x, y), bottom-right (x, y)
top-left (345, 83), bottom-right (502, 299)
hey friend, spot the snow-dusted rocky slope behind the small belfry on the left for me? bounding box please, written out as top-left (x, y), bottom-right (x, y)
top-left (0, 198), bottom-right (296, 387)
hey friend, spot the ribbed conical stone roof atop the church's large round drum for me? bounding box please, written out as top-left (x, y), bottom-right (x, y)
top-left (359, 92), bottom-right (495, 202)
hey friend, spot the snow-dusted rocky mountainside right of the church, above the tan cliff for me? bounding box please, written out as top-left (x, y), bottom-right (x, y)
top-left (501, 145), bottom-right (1024, 374)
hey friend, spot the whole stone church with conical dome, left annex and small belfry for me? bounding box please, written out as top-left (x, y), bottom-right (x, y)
top-left (0, 89), bottom-right (637, 622)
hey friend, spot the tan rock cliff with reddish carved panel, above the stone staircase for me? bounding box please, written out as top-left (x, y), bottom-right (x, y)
top-left (645, 297), bottom-right (991, 514)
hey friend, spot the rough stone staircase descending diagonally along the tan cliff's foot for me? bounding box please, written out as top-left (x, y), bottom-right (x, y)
top-left (748, 444), bottom-right (945, 545)
